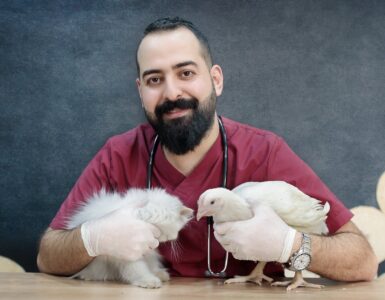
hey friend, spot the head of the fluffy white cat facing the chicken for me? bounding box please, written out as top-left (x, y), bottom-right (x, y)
top-left (138, 189), bottom-right (193, 242)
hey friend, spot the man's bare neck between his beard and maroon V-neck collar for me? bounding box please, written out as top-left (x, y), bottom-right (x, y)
top-left (163, 115), bottom-right (219, 176)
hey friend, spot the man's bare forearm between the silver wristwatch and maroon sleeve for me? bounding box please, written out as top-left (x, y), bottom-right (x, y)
top-left (309, 222), bottom-right (378, 281)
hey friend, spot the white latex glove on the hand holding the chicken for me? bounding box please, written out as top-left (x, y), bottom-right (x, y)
top-left (214, 204), bottom-right (296, 262)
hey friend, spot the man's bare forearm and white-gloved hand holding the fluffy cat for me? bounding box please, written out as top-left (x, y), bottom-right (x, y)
top-left (37, 207), bottom-right (160, 275)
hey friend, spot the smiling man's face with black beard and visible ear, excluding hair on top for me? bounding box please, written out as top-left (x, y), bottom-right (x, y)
top-left (137, 28), bottom-right (223, 154)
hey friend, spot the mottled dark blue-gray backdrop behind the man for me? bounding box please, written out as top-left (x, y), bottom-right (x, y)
top-left (0, 0), bottom-right (385, 271)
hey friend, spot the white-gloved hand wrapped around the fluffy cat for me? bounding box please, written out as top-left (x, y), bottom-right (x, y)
top-left (81, 207), bottom-right (160, 261)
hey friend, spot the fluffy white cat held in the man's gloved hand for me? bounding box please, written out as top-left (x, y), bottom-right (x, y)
top-left (67, 188), bottom-right (193, 288)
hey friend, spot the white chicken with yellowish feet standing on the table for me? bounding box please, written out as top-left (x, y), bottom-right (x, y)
top-left (197, 181), bottom-right (330, 290)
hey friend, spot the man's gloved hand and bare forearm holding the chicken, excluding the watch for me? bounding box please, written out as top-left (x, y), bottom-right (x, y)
top-left (214, 204), bottom-right (378, 281)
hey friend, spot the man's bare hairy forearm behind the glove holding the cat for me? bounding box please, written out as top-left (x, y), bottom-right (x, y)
top-left (37, 228), bottom-right (92, 275)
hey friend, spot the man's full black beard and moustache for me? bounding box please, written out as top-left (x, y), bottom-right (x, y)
top-left (145, 91), bottom-right (216, 155)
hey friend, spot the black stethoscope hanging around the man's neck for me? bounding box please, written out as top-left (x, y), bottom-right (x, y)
top-left (146, 117), bottom-right (229, 278)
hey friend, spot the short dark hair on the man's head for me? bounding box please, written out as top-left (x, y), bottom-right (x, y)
top-left (136, 17), bottom-right (212, 77)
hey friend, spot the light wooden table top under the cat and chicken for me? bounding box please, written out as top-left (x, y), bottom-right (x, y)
top-left (0, 273), bottom-right (385, 300)
